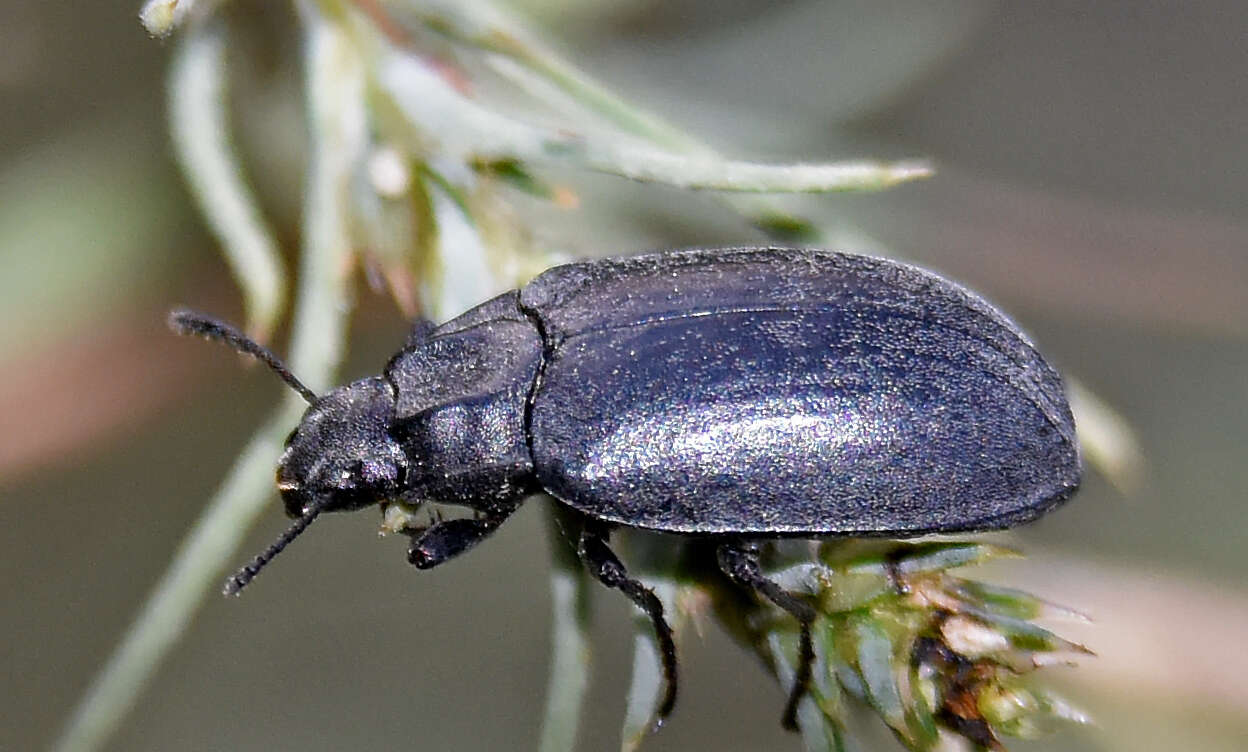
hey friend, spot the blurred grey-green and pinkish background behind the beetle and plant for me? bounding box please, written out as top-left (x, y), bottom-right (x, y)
top-left (0, 0), bottom-right (1248, 752)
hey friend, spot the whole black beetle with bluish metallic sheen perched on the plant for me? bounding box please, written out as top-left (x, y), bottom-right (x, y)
top-left (170, 248), bottom-right (1081, 728)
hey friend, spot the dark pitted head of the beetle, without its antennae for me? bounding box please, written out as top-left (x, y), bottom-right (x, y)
top-left (277, 377), bottom-right (407, 518)
